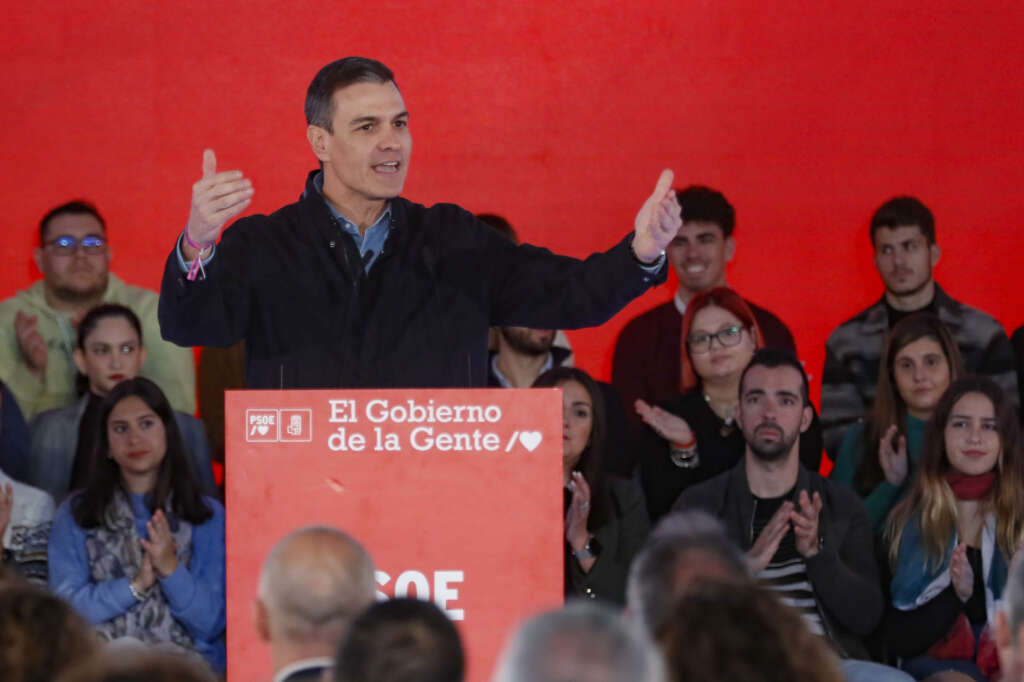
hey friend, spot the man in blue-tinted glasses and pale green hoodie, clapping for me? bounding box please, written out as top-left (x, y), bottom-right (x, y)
top-left (0, 201), bottom-right (196, 419)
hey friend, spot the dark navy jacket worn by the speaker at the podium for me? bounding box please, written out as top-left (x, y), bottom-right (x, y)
top-left (160, 171), bottom-right (666, 388)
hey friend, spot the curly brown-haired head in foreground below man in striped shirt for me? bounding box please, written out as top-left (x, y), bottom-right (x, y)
top-left (657, 582), bottom-right (845, 682)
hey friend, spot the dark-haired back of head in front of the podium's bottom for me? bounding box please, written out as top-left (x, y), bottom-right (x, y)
top-left (333, 598), bottom-right (465, 682)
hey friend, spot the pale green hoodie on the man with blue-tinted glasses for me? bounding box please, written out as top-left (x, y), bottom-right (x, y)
top-left (0, 273), bottom-right (196, 420)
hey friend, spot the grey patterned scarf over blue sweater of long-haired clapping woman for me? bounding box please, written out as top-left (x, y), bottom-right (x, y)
top-left (85, 489), bottom-right (196, 652)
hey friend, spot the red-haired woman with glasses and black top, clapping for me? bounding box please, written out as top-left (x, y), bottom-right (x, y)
top-left (635, 287), bottom-right (821, 523)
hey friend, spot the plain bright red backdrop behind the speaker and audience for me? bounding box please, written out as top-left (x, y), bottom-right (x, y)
top-left (0, 0), bottom-right (1024, 399)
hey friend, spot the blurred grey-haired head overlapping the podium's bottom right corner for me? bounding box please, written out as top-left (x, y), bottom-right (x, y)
top-left (494, 601), bottom-right (666, 682)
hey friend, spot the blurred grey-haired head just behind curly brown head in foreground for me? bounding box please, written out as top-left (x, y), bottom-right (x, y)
top-left (626, 510), bottom-right (754, 637)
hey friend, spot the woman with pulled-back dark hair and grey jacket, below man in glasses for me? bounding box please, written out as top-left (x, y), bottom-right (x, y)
top-left (29, 303), bottom-right (217, 502)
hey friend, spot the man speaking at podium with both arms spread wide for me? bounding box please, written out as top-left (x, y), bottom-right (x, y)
top-left (160, 57), bottom-right (681, 388)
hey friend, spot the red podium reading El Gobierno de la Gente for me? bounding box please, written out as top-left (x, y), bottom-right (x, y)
top-left (225, 389), bottom-right (563, 682)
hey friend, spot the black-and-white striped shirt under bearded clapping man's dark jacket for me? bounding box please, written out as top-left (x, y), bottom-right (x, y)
top-left (751, 487), bottom-right (825, 637)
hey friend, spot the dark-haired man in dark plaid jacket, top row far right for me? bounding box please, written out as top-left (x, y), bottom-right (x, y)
top-left (821, 197), bottom-right (1017, 459)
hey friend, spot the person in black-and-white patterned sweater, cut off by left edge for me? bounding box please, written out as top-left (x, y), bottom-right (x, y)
top-left (0, 462), bottom-right (54, 587)
